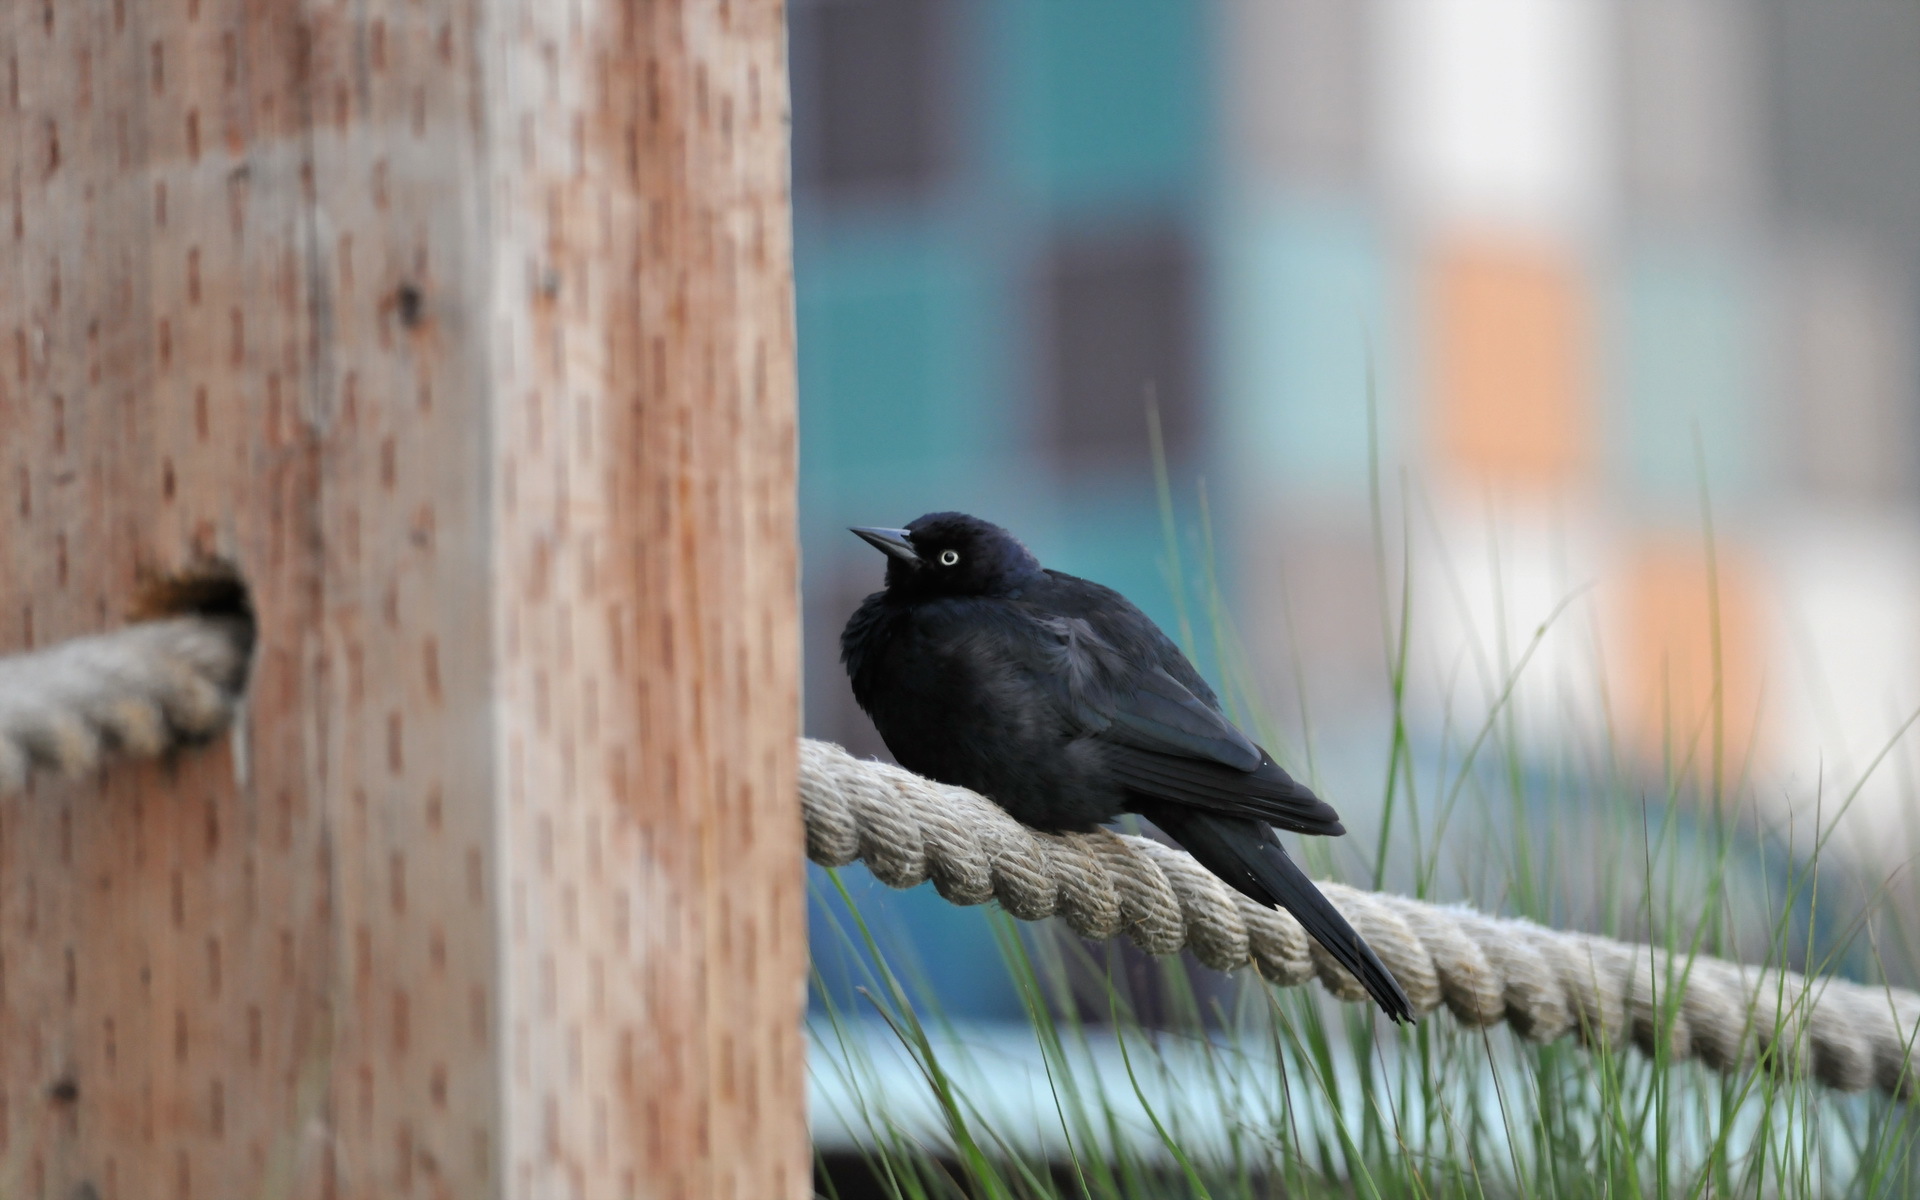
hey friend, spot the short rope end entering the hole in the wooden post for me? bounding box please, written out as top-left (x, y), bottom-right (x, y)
top-left (0, 616), bottom-right (250, 795)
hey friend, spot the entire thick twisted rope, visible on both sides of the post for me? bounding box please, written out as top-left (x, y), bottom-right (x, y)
top-left (0, 616), bottom-right (1920, 1098)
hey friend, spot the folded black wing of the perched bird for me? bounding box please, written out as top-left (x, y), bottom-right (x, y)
top-left (1039, 616), bottom-right (1346, 835)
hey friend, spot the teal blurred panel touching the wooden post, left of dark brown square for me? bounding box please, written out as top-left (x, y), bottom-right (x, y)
top-left (797, 226), bottom-right (1000, 493)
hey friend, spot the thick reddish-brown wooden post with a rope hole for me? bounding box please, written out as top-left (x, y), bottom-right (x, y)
top-left (0, 0), bottom-right (808, 1200)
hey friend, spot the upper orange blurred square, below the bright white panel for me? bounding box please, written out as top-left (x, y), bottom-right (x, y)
top-left (1427, 240), bottom-right (1597, 488)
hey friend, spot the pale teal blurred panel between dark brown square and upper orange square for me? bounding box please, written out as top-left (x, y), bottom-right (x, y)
top-left (1213, 205), bottom-right (1411, 499)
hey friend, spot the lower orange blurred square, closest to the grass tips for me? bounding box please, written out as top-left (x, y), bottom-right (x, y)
top-left (1624, 540), bottom-right (1761, 787)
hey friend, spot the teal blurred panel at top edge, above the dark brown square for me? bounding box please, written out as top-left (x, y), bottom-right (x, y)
top-left (995, 0), bottom-right (1212, 202)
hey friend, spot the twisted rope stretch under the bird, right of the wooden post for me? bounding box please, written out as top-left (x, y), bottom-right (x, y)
top-left (801, 739), bottom-right (1920, 1098)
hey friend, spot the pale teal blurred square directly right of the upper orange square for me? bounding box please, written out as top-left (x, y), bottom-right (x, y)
top-left (1611, 253), bottom-right (1766, 505)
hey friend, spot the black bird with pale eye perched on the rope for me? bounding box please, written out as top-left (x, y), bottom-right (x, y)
top-left (841, 513), bottom-right (1413, 1021)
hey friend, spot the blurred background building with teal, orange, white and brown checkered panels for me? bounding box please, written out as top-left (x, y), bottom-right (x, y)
top-left (791, 0), bottom-right (1920, 1012)
